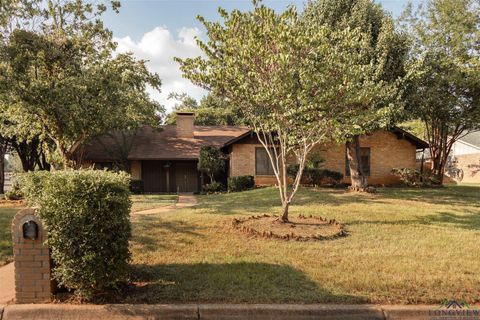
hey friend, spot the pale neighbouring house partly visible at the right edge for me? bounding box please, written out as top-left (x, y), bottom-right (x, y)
top-left (445, 131), bottom-right (480, 183)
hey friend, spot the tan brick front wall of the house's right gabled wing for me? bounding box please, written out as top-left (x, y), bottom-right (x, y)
top-left (230, 131), bottom-right (416, 185)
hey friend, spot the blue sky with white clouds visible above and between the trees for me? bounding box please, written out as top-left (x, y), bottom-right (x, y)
top-left (104, 0), bottom-right (422, 111)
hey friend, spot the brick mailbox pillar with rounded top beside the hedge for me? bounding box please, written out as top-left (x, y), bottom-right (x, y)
top-left (12, 209), bottom-right (52, 303)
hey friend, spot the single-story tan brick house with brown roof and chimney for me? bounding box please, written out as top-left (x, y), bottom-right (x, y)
top-left (84, 112), bottom-right (428, 192)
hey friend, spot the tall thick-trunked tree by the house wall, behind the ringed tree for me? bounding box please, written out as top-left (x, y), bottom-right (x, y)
top-left (302, 0), bottom-right (409, 190)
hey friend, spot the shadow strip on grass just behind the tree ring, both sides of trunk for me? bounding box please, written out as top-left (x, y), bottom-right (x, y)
top-left (193, 187), bottom-right (375, 215)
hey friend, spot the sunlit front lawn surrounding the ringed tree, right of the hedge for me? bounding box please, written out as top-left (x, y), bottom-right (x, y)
top-left (126, 185), bottom-right (480, 303)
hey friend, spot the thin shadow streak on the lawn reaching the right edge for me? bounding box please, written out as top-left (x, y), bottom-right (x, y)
top-left (348, 210), bottom-right (480, 230)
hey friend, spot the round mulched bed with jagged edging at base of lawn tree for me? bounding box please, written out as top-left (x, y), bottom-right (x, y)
top-left (232, 214), bottom-right (347, 241)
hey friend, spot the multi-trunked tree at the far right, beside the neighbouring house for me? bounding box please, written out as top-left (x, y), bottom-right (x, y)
top-left (404, 0), bottom-right (480, 183)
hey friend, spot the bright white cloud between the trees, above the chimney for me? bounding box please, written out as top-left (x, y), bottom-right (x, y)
top-left (115, 26), bottom-right (206, 111)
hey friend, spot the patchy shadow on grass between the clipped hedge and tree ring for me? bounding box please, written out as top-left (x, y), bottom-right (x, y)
top-left (132, 215), bottom-right (204, 251)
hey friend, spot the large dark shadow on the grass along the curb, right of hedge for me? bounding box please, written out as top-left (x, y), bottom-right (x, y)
top-left (125, 262), bottom-right (367, 303)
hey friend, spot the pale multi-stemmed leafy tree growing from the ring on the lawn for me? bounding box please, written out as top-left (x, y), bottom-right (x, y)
top-left (177, 2), bottom-right (400, 222)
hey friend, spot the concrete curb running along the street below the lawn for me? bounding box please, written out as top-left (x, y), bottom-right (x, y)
top-left (0, 304), bottom-right (442, 320)
